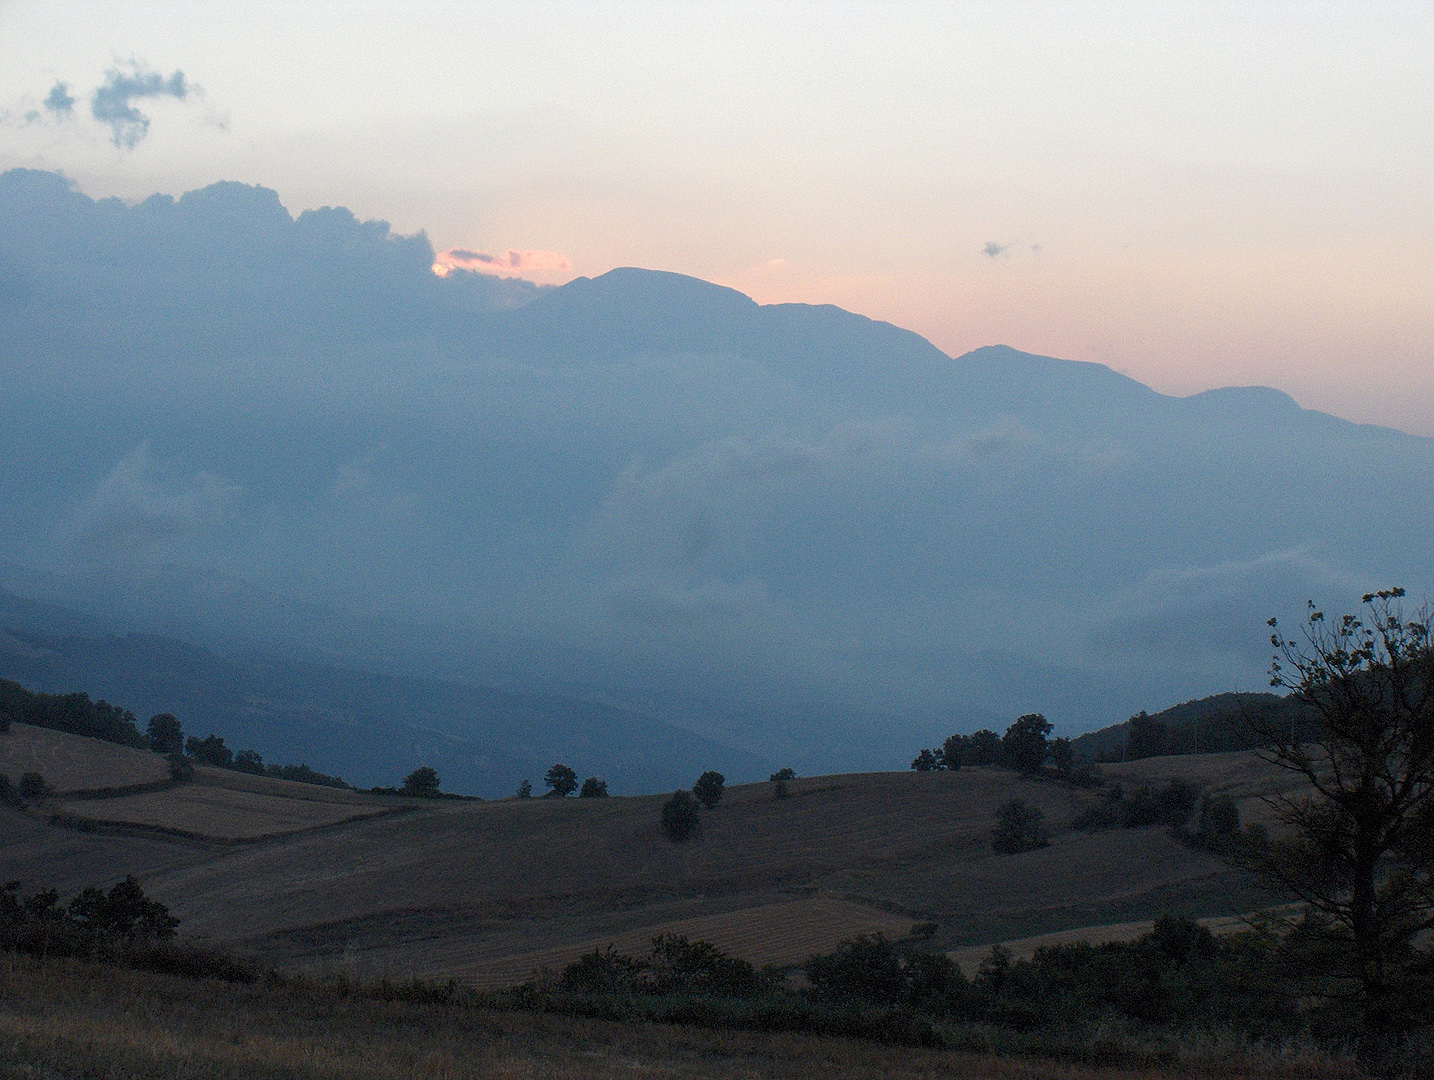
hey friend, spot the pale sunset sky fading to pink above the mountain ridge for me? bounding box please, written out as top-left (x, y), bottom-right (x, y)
top-left (8, 0), bottom-right (1434, 435)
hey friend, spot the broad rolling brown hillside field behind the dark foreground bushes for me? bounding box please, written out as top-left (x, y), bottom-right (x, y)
top-left (0, 725), bottom-right (1296, 985)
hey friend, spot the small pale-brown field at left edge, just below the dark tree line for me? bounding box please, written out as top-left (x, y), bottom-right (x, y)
top-left (0, 724), bottom-right (169, 793)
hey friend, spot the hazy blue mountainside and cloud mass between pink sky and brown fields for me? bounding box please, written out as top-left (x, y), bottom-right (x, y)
top-left (0, 172), bottom-right (1434, 792)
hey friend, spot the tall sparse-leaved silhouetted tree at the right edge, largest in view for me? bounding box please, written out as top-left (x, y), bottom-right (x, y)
top-left (1243, 588), bottom-right (1434, 1056)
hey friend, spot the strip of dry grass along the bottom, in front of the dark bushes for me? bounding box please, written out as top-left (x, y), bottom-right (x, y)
top-left (0, 954), bottom-right (1352, 1080)
